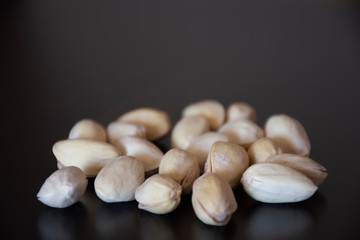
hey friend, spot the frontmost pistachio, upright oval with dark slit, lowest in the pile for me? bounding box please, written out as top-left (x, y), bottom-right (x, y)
top-left (191, 172), bottom-right (237, 226)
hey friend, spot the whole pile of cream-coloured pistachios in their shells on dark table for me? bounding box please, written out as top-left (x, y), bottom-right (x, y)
top-left (37, 100), bottom-right (327, 226)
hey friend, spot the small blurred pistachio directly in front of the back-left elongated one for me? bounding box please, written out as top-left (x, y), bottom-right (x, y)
top-left (106, 121), bottom-right (146, 143)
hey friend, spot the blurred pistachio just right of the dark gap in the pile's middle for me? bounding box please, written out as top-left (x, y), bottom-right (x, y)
top-left (171, 116), bottom-right (210, 149)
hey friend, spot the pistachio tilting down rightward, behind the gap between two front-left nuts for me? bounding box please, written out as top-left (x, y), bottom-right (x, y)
top-left (113, 136), bottom-right (164, 172)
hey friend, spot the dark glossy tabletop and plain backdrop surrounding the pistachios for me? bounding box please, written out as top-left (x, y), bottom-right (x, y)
top-left (0, 0), bottom-right (360, 239)
